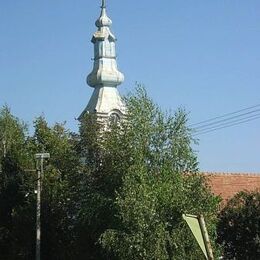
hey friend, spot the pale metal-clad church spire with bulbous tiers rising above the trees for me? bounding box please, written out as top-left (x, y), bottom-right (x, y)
top-left (79, 0), bottom-right (126, 124)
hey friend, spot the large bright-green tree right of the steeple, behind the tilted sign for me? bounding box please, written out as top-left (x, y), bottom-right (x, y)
top-left (77, 87), bottom-right (221, 259)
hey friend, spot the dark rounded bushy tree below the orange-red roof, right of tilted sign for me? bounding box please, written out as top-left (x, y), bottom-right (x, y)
top-left (218, 191), bottom-right (260, 260)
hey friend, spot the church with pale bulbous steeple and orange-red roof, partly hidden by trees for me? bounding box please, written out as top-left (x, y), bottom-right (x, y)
top-left (79, 0), bottom-right (260, 203)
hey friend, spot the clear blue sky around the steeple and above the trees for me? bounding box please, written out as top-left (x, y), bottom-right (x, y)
top-left (0, 0), bottom-right (260, 172)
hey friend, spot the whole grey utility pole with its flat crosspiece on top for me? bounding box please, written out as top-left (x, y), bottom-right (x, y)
top-left (35, 153), bottom-right (50, 260)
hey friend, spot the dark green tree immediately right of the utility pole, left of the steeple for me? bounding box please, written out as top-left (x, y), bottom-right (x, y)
top-left (29, 117), bottom-right (79, 259)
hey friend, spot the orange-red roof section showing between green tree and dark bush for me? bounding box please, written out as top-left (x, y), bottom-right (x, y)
top-left (203, 173), bottom-right (260, 201)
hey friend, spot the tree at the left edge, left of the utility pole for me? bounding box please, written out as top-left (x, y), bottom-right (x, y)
top-left (0, 106), bottom-right (34, 259)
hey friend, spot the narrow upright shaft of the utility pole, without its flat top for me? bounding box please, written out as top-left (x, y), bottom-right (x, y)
top-left (35, 159), bottom-right (42, 260)
